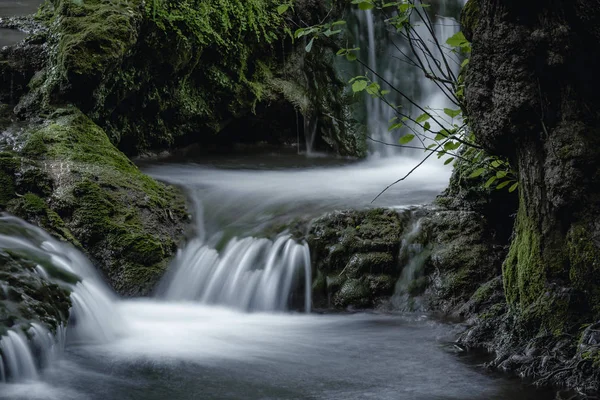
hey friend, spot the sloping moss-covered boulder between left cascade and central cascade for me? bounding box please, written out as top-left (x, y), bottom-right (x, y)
top-left (0, 108), bottom-right (188, 295)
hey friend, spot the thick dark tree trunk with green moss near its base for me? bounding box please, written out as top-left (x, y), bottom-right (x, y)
top-left (466, 0), bottom-right (600, 333)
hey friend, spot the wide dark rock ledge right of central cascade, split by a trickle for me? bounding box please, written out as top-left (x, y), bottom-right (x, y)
top-left (306, 208), bottom-right (507, 317)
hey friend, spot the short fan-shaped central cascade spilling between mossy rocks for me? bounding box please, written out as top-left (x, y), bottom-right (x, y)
top-left (159, 236), bottom-right (311, 312)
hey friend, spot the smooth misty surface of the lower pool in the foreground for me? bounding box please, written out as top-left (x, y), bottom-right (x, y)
top-left (0, 301), bottom-right (552, 400)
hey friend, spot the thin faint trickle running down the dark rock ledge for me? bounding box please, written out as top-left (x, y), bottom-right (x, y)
top-left (391, 219), bottom-right (429, 311)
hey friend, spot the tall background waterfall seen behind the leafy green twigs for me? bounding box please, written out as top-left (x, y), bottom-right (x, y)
top-left (350, 0), bottom-right (463, 157)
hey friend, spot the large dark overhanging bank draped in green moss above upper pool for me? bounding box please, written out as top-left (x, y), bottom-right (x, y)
top-left (8, 0), bottom-right (366, 156)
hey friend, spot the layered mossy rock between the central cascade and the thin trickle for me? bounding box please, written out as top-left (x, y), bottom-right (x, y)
top-left (306, 209), bottom-right (410, 308)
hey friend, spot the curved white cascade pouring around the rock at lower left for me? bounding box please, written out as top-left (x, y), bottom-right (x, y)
top-left (0, 215), bottom-right (124, 382)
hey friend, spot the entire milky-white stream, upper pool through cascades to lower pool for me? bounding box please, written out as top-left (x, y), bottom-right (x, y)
top-left (0, 0), bottom-right (552, 400)
